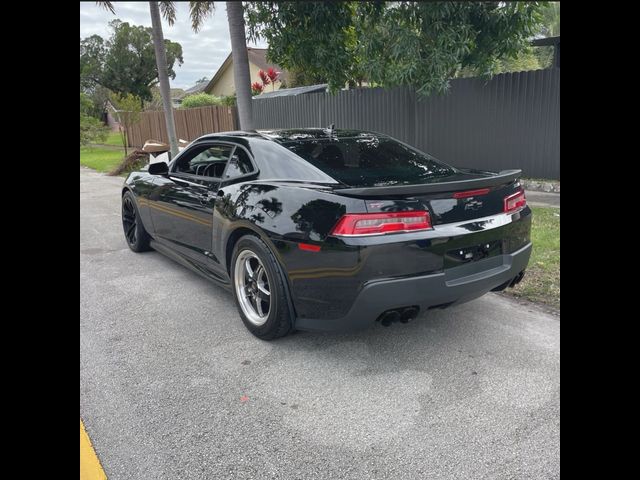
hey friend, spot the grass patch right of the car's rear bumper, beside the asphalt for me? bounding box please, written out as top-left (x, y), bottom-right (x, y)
top-left (504, 207), bottom-right (560, 310)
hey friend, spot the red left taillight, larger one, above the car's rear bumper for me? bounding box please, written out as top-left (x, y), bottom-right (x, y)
top-left (330, 210), bottom-right (431, 237)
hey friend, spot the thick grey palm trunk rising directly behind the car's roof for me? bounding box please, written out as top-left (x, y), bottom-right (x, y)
top-left (226, 2), bottom-right (255, 130)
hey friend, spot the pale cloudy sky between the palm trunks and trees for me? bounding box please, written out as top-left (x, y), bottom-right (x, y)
top-left (80, 2), bottom-right (267, 89)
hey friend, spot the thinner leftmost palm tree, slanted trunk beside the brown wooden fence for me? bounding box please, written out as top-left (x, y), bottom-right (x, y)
top-left (96, 2), bottom-right (178, 156)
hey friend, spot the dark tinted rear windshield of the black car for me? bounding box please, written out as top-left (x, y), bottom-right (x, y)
top-left (282, 135), bottom-right (455, 187)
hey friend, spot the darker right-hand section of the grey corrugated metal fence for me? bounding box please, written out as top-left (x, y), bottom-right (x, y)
top-left (415, 69), bottom-right (560, 179)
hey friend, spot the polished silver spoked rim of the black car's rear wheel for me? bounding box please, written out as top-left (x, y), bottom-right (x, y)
top-left (234, 250), bottom-right (271, 326)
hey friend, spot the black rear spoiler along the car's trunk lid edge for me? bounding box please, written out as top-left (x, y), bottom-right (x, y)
top-left (336, 170), bottom-right (522, 197)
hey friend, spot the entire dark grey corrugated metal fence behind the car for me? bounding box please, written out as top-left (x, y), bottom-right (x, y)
top-left (253, 68), bottom-right (560, 179)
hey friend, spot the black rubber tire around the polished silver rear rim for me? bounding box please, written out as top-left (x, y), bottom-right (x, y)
top-left (230, 235), bottom-right (293, 340)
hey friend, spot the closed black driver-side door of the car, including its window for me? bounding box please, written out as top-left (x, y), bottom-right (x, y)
top-left (149, 142), bottom-right (233, 269)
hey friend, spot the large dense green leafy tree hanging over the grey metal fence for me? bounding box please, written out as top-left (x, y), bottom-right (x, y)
top-left (246, 1), bottom-right (542, 95)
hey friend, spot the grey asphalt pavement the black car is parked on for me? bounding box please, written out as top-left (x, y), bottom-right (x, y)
top-left (80, 168), bottom-right (560, 480)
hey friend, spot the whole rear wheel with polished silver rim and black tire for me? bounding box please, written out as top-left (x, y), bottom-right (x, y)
top-left (231, 235), bottom-right (292, 340)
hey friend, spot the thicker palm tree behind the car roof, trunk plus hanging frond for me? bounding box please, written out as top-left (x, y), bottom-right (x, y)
top-left (189, 1), bottom-right (255, 130)
